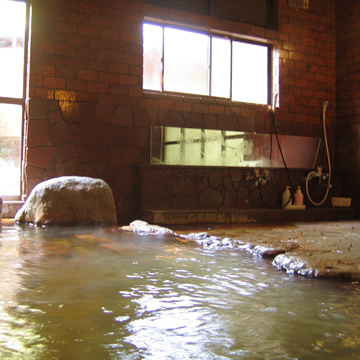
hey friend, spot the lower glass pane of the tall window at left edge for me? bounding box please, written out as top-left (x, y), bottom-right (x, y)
top-left (0, 104), bottom-right (22, 195)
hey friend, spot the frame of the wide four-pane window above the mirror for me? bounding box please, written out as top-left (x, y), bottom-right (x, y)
top-left (142, 18), bottom-right (275, 105)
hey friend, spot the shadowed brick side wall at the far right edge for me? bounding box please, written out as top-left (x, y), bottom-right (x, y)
top-left (336, 0), bottom-right (360, 211)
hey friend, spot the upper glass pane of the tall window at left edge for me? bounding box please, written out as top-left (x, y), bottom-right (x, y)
top-left (0, 1), bottom-right (26, 98)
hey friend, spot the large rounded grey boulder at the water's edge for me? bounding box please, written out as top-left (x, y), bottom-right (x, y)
top-left (15, 176), bottom-right (117, 225)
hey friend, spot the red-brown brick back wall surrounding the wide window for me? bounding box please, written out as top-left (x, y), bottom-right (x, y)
top-left (24, 0), bottom-right (336, 222)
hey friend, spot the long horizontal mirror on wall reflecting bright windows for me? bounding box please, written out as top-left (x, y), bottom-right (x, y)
top-left (150, 126), bottom-right (321, 169)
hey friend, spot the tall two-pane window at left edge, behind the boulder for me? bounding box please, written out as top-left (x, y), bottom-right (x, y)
top-left (0, 0), bottom-right (26, 198)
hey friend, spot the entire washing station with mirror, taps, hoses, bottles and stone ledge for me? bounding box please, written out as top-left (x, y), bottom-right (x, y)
top-left (139, 112), bottom-right (355, 224)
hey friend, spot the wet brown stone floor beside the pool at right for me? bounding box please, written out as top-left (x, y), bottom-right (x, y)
top-left (172, 220), bottom-right (360, 280)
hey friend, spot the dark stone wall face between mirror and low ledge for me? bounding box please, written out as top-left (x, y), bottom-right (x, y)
top-left (139, 166), bottom-right (309, 210)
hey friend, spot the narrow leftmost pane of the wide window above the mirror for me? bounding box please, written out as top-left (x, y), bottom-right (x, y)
top-left (143, 24), bottom-right (163, 91)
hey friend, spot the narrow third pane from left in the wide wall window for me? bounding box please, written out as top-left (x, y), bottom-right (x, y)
top-left (211, 38), bottom-right (231, 98)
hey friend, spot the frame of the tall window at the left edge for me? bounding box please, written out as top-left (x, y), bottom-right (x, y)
top-left (0, 0), bottom-right (30, 201)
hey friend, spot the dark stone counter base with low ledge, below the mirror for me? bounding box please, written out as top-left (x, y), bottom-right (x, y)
top-left (138, 166), bottom-right (356, 225)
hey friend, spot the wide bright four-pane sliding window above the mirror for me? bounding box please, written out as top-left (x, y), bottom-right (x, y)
top-left (143, 23), bottom-right (271, 104)
